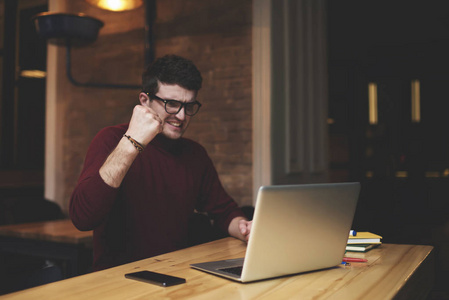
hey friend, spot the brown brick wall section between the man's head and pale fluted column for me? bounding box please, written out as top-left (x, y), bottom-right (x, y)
top-left (155, 0), bottom-right (252, 205)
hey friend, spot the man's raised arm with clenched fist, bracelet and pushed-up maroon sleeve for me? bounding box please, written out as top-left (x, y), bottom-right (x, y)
top-left (69, 105), bottom-right (162, 230)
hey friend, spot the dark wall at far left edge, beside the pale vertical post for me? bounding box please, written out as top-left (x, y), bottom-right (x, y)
top-left (0, 1), bottom-right (47, 201)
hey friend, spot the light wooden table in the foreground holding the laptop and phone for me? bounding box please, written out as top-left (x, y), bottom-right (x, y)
top-left (0, 238), bottom-right (434, 300)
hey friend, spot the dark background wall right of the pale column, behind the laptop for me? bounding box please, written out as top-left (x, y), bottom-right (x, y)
top-left (328, 0), bottom-right (449, 299)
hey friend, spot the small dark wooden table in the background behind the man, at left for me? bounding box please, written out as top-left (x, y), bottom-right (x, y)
top-left (0, 220), bottom-right (92, 277)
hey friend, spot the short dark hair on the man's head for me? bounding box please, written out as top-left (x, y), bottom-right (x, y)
top-left (142, 54), bottom-right (203, 94)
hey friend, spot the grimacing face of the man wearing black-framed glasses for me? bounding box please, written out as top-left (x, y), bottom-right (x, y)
top-left (143, 83), bottom-right (196, 139)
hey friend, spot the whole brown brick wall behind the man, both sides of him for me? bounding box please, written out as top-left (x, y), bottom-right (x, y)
top-left (58, 0), bottom-right (252, 209)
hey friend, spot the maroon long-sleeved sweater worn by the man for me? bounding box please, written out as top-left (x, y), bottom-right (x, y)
top-left (70, 124), bottom-right (243, 270)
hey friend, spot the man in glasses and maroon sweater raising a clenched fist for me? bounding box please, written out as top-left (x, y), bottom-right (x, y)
top-left (70, 55), bottom-right (251, 270)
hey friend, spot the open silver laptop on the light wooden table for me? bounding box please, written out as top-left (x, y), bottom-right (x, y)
top-left (190, 182), bottom-right (360, 282)
